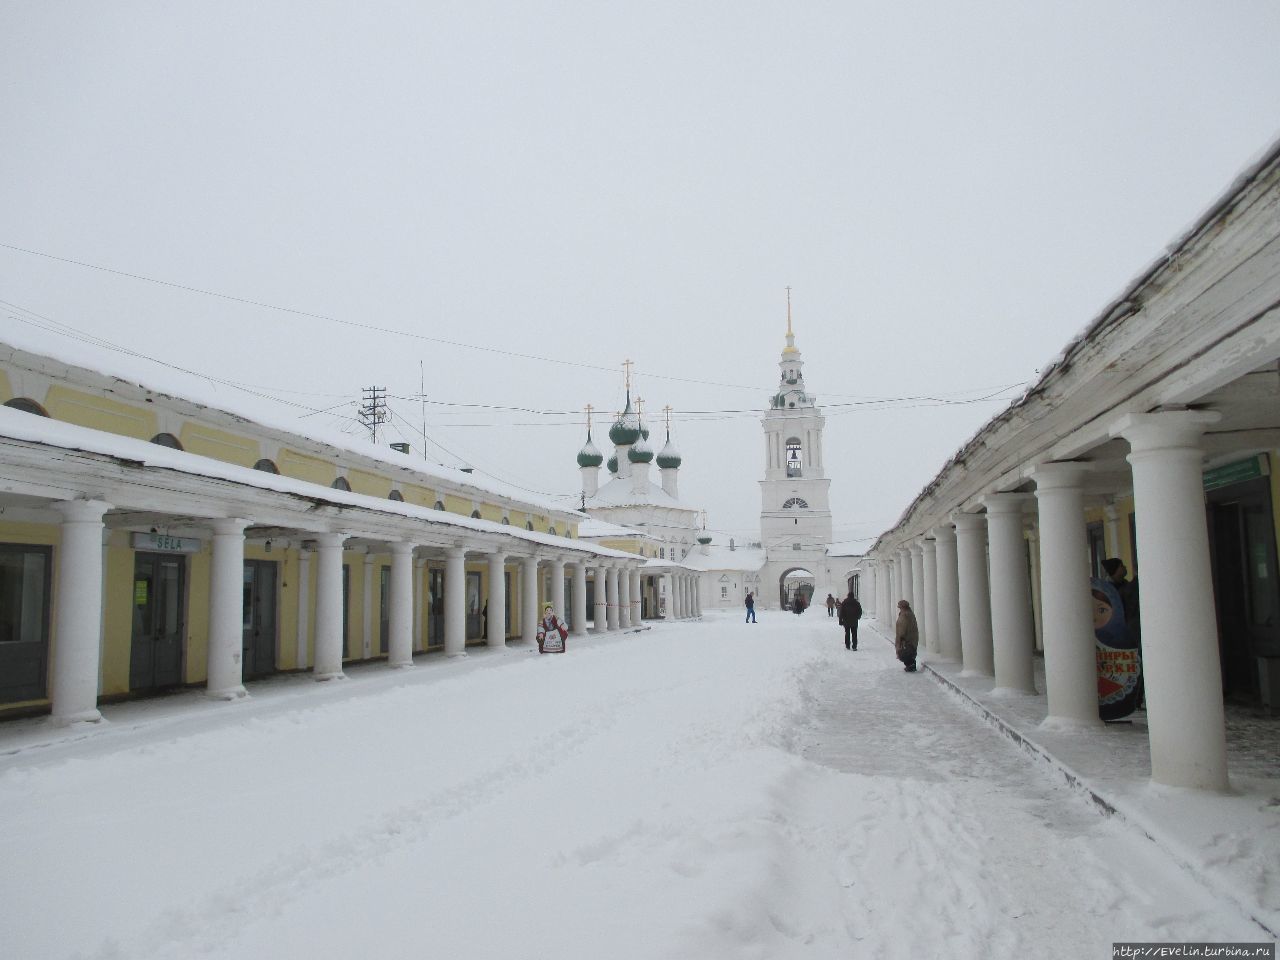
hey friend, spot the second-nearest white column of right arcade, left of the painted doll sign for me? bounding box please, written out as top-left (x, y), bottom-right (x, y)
top-left (1032, 463), bottom-right (1102, 728)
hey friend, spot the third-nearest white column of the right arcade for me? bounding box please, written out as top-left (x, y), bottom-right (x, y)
top-left (982, 493), bottom-right (1036, 694)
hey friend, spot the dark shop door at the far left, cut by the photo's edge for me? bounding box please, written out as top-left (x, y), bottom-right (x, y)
top-left (0, 544), bottom-right (51, 703)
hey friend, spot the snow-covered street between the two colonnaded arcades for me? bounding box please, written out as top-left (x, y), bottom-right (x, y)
top-left (0, 611), bottom-right (1261, 960)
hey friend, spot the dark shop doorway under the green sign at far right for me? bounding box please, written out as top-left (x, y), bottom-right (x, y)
top-left (1208, 477), bottom-right (1280, 700)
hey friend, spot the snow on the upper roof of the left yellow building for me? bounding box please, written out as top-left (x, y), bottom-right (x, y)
top-left (0, 330), bottom-right (572, 527)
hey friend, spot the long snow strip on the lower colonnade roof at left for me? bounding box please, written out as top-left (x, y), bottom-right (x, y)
top-left (0, 406), bottom-right (635, 559)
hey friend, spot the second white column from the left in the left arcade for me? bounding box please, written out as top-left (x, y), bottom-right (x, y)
top-left (205, 520), bottom-right (248, 700)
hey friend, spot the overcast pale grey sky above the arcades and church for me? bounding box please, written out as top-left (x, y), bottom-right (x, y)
top-left (0, 0), bottom-right (1280, 539)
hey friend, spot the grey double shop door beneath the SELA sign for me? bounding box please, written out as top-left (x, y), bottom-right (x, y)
top-left (129, 553), bottom-right (187, 691)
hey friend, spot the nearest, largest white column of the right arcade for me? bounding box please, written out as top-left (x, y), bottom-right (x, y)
top-left (1112, 411), bottom-right (1229, 790)
